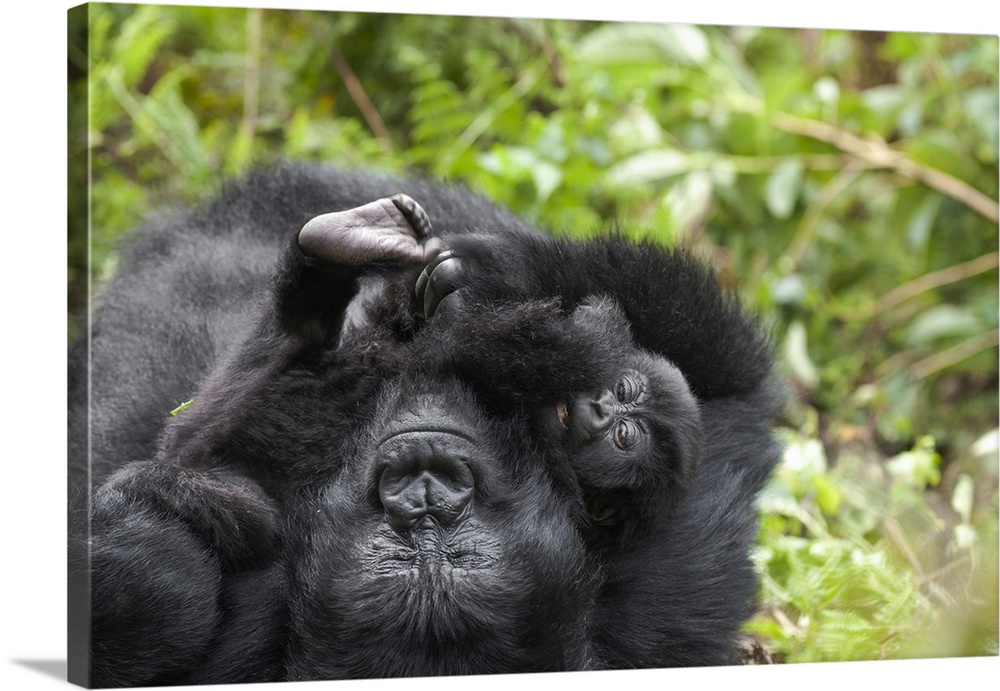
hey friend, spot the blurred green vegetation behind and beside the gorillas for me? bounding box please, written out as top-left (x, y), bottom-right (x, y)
top-left (69, 4), bottom-right (1000, 662)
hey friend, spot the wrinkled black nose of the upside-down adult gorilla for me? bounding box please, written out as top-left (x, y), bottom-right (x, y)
top-left (379, 432), bottom-right (475, 533)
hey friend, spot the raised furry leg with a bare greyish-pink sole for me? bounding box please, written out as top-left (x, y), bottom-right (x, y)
top-left (160, 195), bottom-right (435, 470)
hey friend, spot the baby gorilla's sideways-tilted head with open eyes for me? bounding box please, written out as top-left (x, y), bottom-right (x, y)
top-left (535, 302), bottom-right (702, 538)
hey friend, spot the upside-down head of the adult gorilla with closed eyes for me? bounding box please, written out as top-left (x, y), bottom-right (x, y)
top-left (289, 376), bottom-right (596, 679)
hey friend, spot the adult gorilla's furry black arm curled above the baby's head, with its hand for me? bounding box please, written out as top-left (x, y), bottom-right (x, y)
top-left (418, 231), bottom-right (771, 399)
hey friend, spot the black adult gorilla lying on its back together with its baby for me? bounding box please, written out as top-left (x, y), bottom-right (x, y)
top-left (70, 166), bottom-right (778, 686)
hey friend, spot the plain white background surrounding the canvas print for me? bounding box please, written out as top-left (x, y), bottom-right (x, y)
top-left (0, 0), bottom-right (1000, 691)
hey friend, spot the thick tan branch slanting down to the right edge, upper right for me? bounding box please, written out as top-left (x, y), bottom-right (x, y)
top-left (771, 113), bottom-right (1000, 223)
